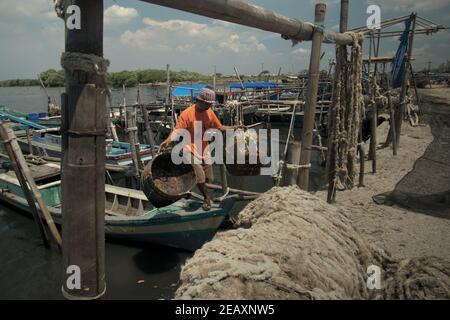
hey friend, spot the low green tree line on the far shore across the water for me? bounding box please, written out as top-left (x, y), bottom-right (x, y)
top-left (0, 69), bottom-right (211, 88)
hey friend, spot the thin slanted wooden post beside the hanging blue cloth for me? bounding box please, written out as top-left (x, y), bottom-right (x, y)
top-left (395, 12), bottom-right (417, 148)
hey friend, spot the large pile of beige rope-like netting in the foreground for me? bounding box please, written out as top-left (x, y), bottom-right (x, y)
top-left (176, 186), bottom-right (450, 299)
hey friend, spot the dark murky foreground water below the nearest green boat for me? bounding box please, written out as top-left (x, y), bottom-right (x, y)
top-left (0, 206), bottom-right (192, 299)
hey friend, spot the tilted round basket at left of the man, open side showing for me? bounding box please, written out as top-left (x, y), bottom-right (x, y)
top-left (141, 152), bottom-right (197, 208)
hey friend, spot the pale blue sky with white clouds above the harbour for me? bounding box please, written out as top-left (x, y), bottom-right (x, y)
top-left (0, 0), bottom-right (450, 80)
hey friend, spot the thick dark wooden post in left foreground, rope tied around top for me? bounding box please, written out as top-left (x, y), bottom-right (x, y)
top-left (61, 0), bottom-right (106, 300)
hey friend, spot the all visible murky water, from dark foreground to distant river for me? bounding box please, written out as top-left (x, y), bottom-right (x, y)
top-left (0, 87), bottom-right (324, 299)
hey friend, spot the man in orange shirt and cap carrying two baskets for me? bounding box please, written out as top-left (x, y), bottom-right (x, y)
top-left (160, 88), bottom-right (245, 211)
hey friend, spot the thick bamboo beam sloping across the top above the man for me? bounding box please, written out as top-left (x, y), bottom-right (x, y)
top-left (141, 0), bottom-right (353, 45)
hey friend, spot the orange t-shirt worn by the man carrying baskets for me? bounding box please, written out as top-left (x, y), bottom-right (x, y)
top-left (175, 104), bottom-right (222, 159)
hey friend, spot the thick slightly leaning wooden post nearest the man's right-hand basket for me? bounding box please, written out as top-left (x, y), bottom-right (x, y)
top-left (297, 3), bottom-right (326, 190)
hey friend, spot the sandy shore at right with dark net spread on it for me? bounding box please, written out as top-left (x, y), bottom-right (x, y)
top-left (317, 88), bottom-right (450, 260)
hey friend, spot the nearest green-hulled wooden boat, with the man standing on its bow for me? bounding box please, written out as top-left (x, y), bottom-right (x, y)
top-left (0, 163), bottom-right (235, 251)
